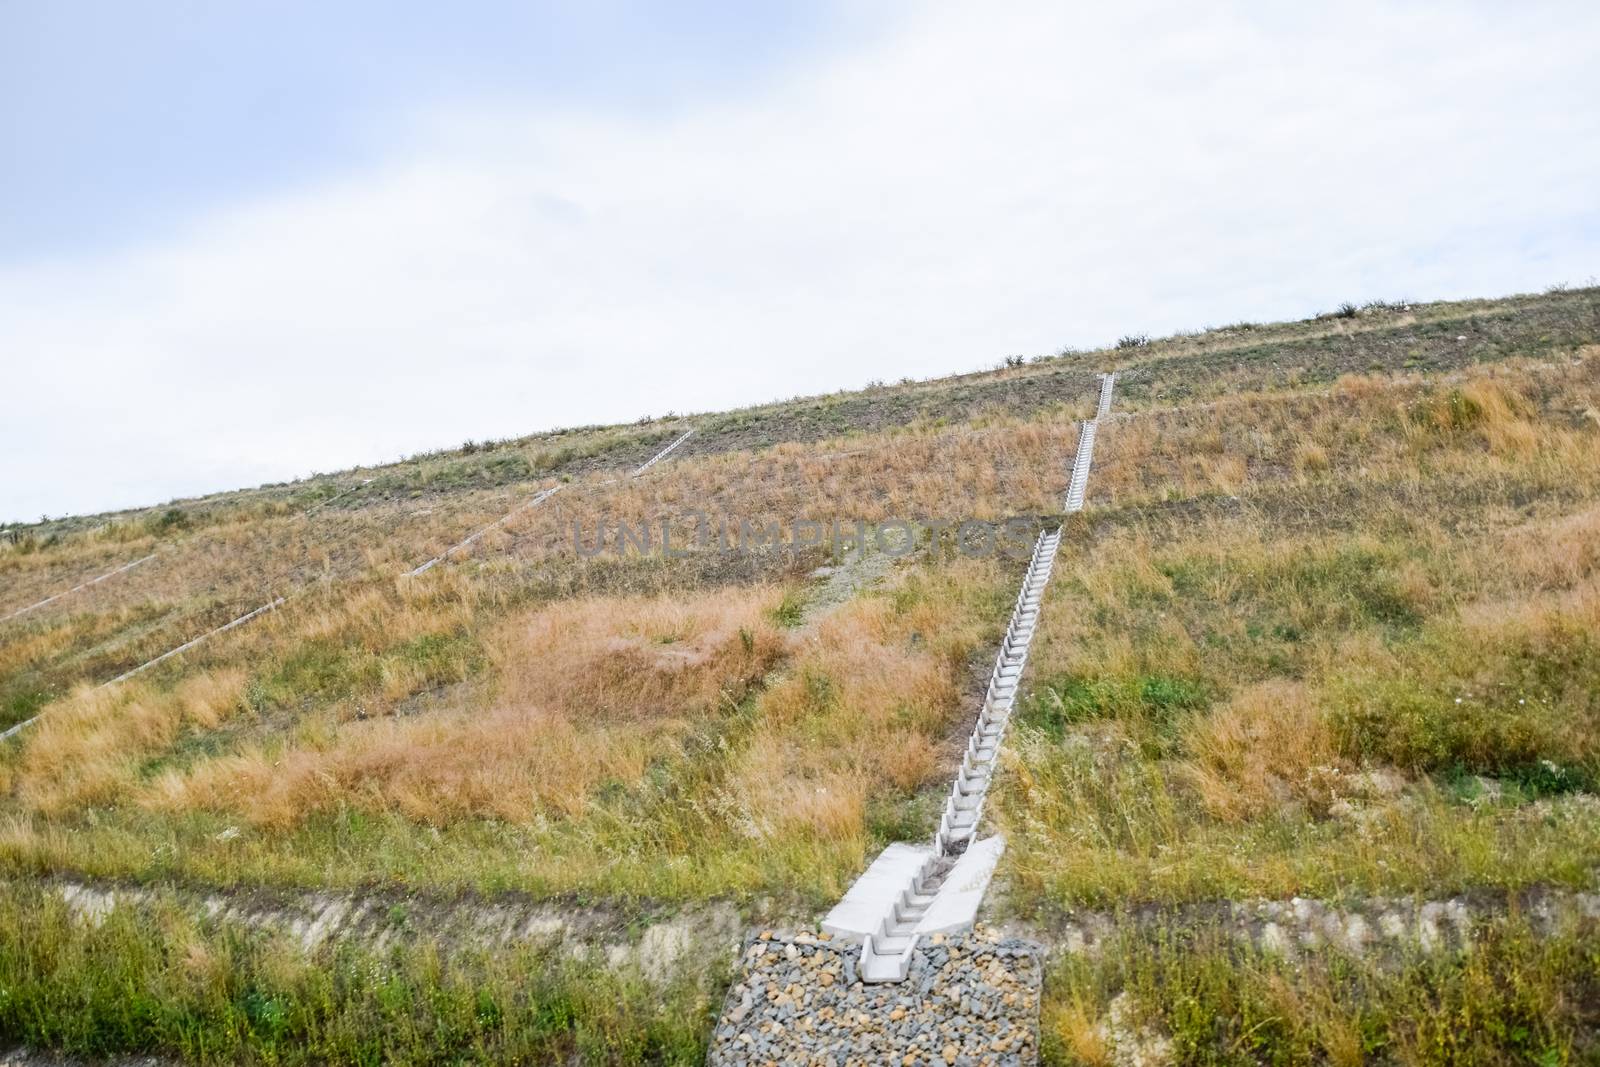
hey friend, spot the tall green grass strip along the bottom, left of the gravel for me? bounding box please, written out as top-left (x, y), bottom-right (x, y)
top-left (0, 886), bottom-right (722, 1064)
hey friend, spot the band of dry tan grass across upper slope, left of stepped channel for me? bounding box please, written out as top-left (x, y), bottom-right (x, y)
top-left (0, 406), bottom-right (1077, 624)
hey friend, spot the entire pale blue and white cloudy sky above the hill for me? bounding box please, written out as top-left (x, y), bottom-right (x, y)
top-left (0, 0), bottom-right (1600, 520)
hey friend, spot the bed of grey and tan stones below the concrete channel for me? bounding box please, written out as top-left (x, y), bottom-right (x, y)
top-left (706, 926), bottom-right (1042, 1067)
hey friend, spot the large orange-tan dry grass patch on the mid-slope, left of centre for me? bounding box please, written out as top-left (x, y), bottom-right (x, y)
top-left (144, 587), bottom-right (784, 827)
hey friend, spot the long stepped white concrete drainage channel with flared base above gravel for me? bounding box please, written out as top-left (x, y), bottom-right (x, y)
top-left (822, 374), bottom-right (1115, 982)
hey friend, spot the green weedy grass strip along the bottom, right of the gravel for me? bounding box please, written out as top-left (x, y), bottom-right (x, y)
top-left (1043, 920), bottom-right (1600, 1067)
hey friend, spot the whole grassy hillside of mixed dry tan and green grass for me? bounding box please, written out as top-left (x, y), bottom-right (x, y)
top-left (0, 291), bottom-right (1600, 1059)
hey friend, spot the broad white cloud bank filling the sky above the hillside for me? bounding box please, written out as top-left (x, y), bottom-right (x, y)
top-left (0, 3), bottom-right (1600, 517)
